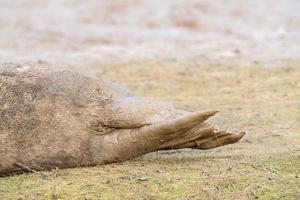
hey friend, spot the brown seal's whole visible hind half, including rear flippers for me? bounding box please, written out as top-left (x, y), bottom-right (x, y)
top-left (0, 63), bottom-right (245, 176)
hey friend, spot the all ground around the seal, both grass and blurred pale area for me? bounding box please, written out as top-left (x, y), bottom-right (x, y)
top-left (0, 0), bottom-right (300, 200)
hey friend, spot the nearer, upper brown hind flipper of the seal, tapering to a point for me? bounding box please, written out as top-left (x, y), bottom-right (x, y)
top-left (90, 111), bottom-right (217, 164)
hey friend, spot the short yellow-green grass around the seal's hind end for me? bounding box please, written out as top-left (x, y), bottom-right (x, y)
top-left (0, 58), bottom-right (300, 200)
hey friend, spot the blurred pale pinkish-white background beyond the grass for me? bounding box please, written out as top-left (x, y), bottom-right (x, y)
top-left (0, 0), bottom-right (300, 65)
